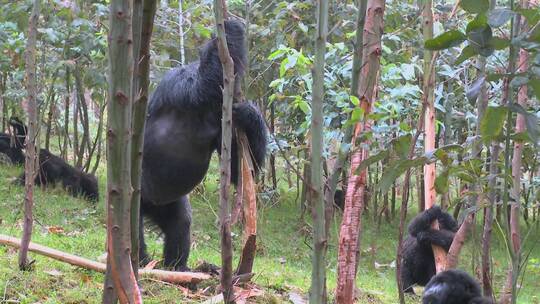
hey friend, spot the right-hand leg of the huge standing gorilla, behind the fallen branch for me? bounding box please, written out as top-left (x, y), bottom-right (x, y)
top-left (141, 196), bottom-right (191, 271)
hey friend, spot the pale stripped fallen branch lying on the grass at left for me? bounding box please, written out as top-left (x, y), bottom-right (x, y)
top-left (0, 234), bottom-right (210, 284)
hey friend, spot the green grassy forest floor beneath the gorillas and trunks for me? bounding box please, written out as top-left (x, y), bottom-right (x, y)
top-left (0, 162), bottom-right (540, 304)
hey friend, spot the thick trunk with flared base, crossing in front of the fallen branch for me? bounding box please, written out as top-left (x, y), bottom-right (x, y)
top-left (103, 0), bottom-right (142, 303)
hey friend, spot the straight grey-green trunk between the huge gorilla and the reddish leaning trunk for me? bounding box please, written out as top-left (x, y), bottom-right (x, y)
top-left (308, 0), bottom-right (328, 304)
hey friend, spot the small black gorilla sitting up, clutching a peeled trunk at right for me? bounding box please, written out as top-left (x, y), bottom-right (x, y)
top-left (401, 206), bottom-right (458, 293)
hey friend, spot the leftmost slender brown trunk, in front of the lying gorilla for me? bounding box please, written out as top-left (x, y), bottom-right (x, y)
top-left (19, 0), bottom-right (41, 270)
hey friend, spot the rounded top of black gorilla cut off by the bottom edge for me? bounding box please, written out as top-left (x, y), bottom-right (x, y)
top-left (422, 269), bottom-right (493, 304)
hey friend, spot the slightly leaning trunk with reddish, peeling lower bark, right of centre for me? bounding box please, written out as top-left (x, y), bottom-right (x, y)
top-left (336, 0), bottom-right (385, 304)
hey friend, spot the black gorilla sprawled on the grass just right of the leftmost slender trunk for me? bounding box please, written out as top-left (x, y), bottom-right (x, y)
top-left (18, 149), bottom-right (99, 201)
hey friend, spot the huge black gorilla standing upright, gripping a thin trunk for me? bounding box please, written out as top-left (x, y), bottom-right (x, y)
top-left (139, 21), bottom-right (266, 270)
